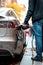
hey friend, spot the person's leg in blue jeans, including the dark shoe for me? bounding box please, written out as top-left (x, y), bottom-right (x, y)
top-left (32, 20), bottom-right (42, 61)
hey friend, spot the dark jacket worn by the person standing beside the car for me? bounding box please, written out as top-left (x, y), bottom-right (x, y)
top-left (24, 0), bottom-right (43, 24)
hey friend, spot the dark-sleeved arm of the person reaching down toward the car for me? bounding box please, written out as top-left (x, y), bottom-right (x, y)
top-left (24, 0), bottom-right (36, 24)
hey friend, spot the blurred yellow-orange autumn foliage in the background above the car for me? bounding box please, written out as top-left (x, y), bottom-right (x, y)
top-left (5, 0), bottom-right (26, 21)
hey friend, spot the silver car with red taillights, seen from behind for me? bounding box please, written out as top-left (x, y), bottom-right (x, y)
top-left (0, 8), bottom-right (26, 61)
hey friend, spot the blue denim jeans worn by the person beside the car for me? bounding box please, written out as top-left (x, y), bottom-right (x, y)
top-left (33, 19), bottom-right (43, 55)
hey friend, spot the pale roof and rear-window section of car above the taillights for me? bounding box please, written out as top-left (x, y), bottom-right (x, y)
top-left (0, 8), bottom-right (18, 20)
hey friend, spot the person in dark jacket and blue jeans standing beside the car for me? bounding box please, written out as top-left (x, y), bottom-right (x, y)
top-left (23, 0), bottom-right (43, 61)
